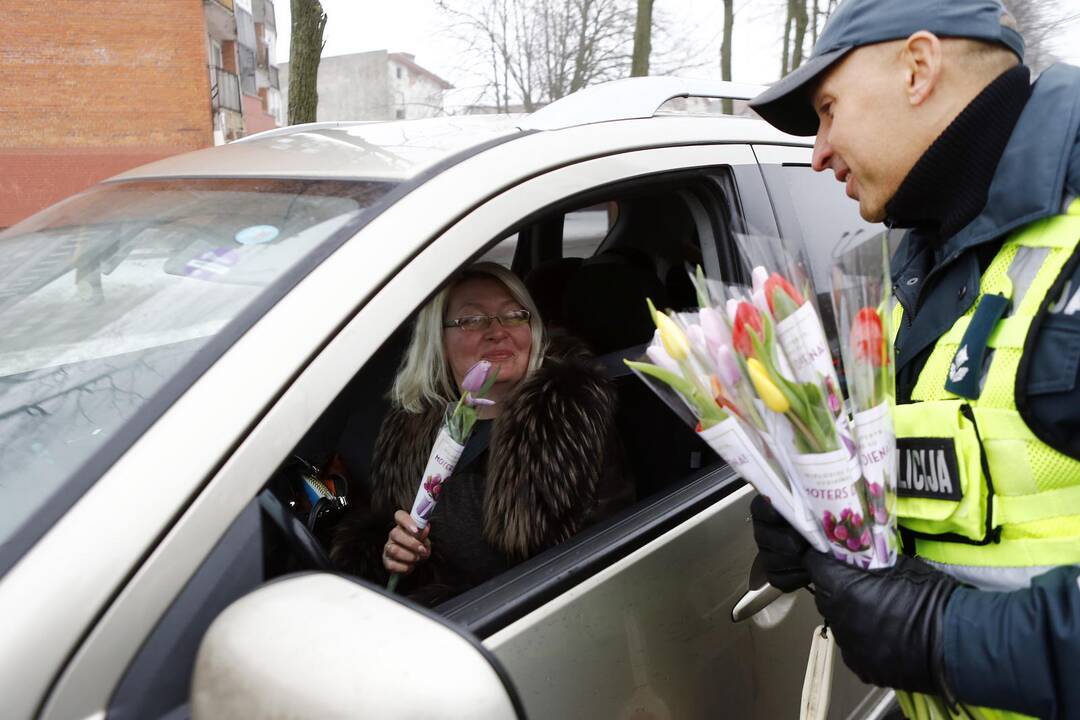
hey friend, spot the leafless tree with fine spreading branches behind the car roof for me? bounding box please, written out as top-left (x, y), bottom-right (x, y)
top-left (438, 0), bottom-right (636, 112)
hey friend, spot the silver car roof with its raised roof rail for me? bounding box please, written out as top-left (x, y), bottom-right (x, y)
top-left (108, 78), bottom-right (806, 182)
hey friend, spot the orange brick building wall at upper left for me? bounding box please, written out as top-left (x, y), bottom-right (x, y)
top-left (0, 0), bottom-right (213, 228)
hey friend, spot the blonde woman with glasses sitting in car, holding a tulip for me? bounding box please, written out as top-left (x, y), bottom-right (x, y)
top-left (330, 262), bottom-right (633, 603)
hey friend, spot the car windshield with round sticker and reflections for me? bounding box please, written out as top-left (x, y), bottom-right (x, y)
top-left (0, 179), bottom-right (394, 572)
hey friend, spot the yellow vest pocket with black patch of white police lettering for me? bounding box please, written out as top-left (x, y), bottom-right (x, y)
top-left (895, 399), bottom-right (993, 544)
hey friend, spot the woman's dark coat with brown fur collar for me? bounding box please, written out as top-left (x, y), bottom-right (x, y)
top-left (330, 341), bottom-right (634, 604)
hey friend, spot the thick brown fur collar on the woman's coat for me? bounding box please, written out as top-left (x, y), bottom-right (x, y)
top-left (372, 334), bottom-right (613, 560)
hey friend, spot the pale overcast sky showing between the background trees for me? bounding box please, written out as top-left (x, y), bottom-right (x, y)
top-left (274, 0), bottom-right (1080, 106)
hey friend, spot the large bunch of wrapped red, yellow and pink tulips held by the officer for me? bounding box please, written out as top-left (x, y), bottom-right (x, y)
top-left (627, 234), bottom-right (896, 568)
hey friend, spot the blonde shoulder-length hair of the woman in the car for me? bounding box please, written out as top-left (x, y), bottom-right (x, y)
top-left (390, 262), bottom-right (546, 412)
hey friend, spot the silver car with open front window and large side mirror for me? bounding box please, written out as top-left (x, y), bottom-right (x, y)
top-left (0, 78), bottom-right (893, 719)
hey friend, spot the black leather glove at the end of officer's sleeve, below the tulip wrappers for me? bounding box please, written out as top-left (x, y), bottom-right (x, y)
top-left (805, 551), bottom-right (959, 704)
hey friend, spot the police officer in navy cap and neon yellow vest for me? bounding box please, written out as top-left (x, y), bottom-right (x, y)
top-left (752, 0), bottom-right (1080, 718)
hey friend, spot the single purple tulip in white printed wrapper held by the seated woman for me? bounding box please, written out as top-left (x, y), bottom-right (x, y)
top-left (387, 361), bottom-right (499, 593)
